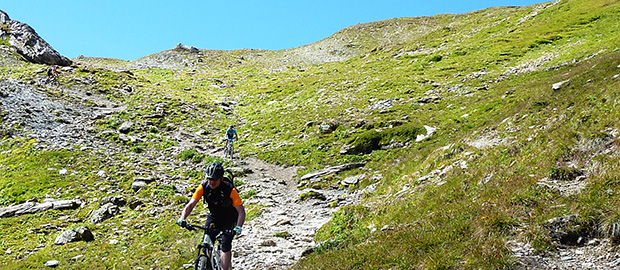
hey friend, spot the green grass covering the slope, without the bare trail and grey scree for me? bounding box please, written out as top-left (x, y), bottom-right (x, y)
top-left (0, 0), bottom-right (620, 269)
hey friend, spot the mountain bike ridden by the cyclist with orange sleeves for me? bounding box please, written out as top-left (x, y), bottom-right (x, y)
top-left (185, 223), bottom-right (235, 270)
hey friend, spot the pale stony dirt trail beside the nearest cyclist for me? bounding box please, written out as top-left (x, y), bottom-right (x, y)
top-left (233, 158), bottom-right (345, 269)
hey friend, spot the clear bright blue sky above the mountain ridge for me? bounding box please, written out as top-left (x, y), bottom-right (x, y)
top-left (0, 0), bottom-right (547, 60)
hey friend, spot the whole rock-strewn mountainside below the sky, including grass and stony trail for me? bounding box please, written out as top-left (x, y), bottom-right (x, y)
top-left (0, 0), bottom-right (620, 269)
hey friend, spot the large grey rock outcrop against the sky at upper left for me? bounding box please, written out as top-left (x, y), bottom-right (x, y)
top-left (0, 10), bottom-right (72, 66)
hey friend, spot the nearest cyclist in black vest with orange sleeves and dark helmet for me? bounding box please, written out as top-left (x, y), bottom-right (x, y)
top-left (177, 163), bottom-right (245, 269)
